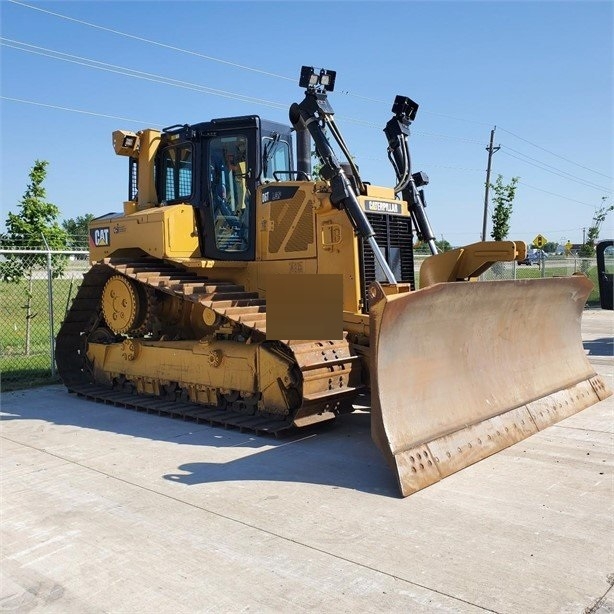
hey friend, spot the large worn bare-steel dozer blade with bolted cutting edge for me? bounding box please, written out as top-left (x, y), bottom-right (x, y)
top-left (370, 276), bottom-right (611, 496)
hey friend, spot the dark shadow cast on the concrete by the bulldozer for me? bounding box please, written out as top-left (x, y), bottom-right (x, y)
top-left (0, 386), bottom-right (399, 497)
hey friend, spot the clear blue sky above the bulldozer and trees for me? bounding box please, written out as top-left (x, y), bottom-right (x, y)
top-left (0, 0), bottom-right (614, 245)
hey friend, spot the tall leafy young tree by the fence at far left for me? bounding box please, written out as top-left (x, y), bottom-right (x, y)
top-left (0, 160), bottom-right (67, 281)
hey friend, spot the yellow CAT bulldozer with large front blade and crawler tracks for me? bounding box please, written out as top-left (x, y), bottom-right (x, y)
top-left (56, 67), bottom-right (611, 496)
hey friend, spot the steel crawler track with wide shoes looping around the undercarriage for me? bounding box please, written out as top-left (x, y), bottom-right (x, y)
top-left (56, 258), bottom-right (363, 435)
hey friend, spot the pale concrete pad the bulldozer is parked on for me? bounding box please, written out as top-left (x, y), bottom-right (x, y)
top-left (0, 310), bottom-right (614, 613)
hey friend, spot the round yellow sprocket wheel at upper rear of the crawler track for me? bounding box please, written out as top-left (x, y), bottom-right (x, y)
top-left (102, 275), bottom-right (147, 335)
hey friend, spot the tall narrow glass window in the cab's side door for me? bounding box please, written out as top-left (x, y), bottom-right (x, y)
top-left (208, 135), bottom-right (253, 252)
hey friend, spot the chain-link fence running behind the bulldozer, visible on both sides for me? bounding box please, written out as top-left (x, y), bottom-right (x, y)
top-left (0, 250), bottom-right (599, 390)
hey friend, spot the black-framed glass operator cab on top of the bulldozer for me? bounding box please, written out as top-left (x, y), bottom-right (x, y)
top-left (155, 115), bottom-right (296, 261)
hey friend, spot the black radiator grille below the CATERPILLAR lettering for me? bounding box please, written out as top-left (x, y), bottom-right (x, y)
top-left (360, 213), bottom-right (415, 313)
